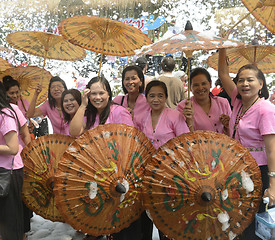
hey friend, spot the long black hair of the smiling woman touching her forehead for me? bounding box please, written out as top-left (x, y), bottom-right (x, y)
top-left (85, 76), bottom-right (113, 129)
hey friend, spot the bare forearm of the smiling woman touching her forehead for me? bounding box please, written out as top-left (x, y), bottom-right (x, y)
top-left (69, 89), bottom-right (90, 137)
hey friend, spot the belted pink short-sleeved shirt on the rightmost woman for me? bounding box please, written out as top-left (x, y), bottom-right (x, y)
top-left (229, 87), bottom-right (275, 166)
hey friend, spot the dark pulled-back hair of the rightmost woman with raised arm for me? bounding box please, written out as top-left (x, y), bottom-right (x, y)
top-left (236, 64), bottom-right (269, 99)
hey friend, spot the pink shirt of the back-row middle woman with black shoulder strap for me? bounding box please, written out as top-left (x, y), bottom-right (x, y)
top-left (113, 93), bottom-right (150, 127)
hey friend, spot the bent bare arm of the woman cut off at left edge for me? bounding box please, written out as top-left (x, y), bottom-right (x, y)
top-left (0, 131), bottom-right (19, 155)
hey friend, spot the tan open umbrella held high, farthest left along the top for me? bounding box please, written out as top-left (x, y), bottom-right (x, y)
top-left (7, 31), bottom-right (86, 68)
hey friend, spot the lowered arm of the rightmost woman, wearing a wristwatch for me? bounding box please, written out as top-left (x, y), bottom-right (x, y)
top-left (264, 134), bottom-right (275, 205)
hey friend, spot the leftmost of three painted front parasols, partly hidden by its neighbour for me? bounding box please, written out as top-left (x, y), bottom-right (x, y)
top-left (21, 134), bottom-right (73, 221)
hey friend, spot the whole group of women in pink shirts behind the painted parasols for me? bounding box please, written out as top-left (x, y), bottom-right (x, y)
top-left (0, 50), bottom-right (275, 240)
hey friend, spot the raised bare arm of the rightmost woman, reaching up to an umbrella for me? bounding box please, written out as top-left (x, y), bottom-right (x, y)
top-left (218, 48), bottom-right (235, 98)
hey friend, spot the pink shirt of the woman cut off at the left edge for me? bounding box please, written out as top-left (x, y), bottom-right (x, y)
top-left (0, 108), bottom-right (19, 169)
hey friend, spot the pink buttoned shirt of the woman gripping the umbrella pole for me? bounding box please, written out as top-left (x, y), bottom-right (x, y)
top-left (177, 96), bottom-right (231, 133)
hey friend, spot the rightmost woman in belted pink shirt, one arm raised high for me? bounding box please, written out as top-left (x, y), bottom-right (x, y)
top-left (219, 49), bottom-right (275, 240)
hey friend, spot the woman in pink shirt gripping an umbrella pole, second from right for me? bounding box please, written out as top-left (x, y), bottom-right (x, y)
top-left (177, 68), bottom-right (231, 135)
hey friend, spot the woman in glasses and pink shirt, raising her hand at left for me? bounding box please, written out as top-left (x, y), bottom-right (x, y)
top-left (27, 76), bottom-right (67, 134)
